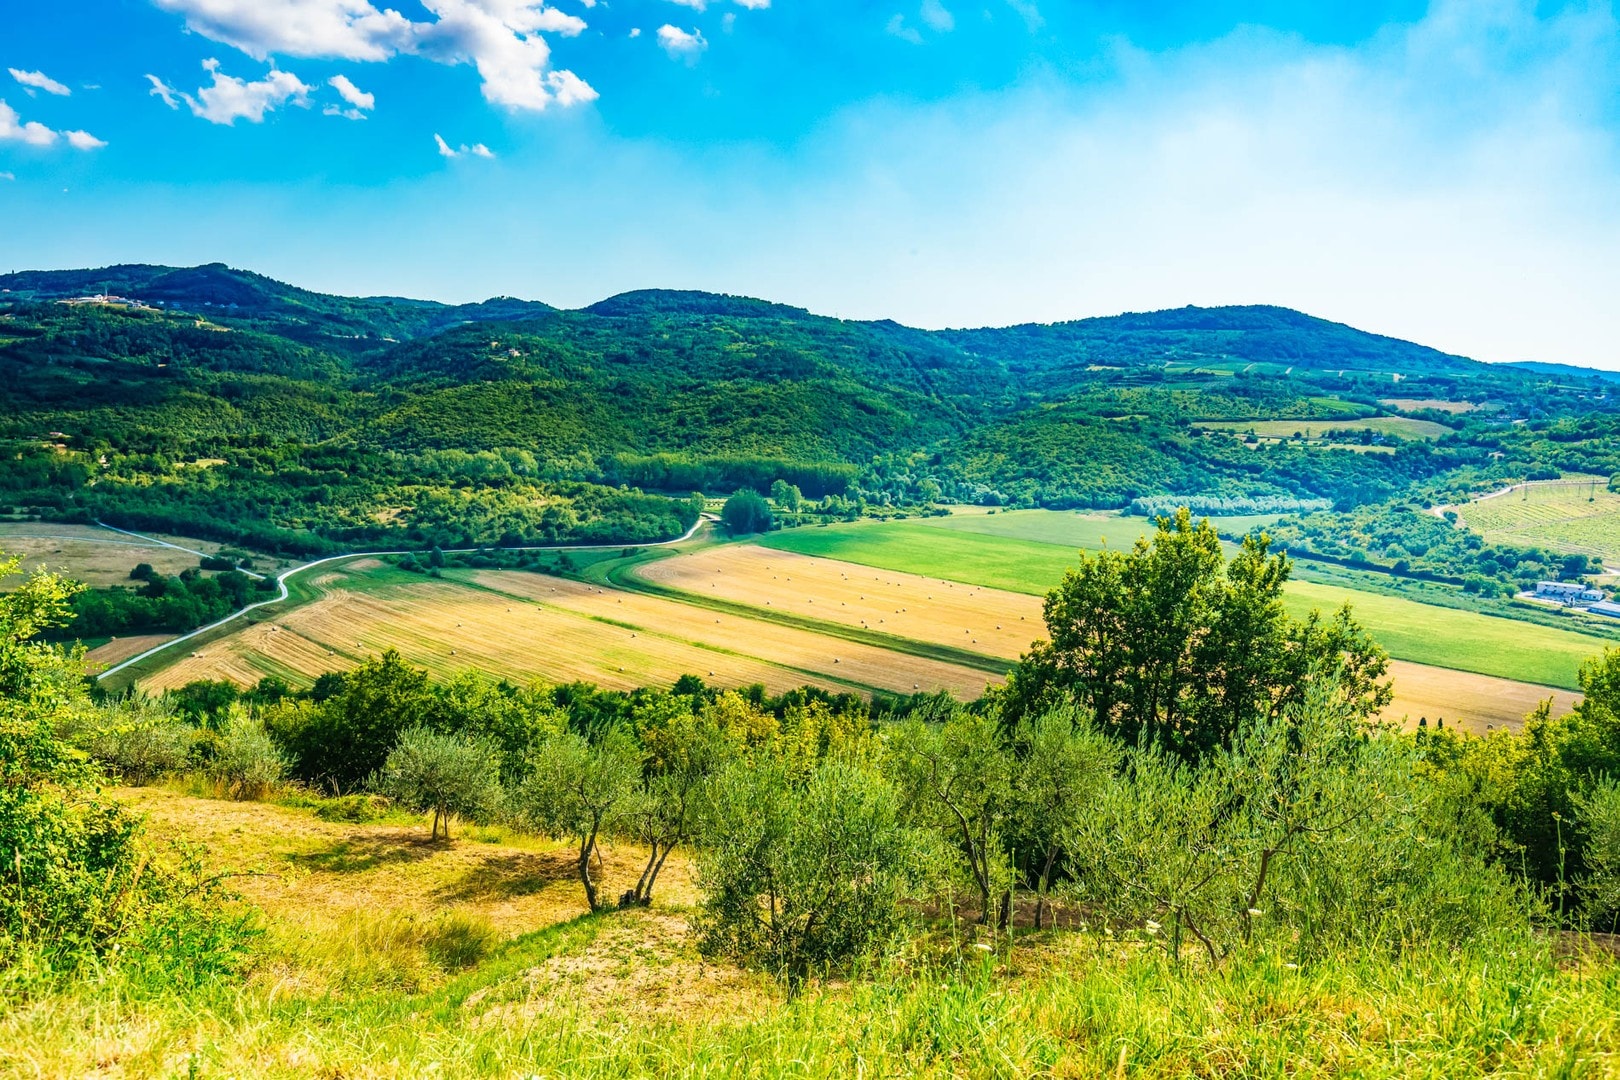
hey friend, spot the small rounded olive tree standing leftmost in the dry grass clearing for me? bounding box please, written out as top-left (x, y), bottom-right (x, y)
top-left (373, 727), bottom-right (502, 840)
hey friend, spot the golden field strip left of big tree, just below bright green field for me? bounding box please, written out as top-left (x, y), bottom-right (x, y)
top-left (637, 544), bottom-right (1047, 661)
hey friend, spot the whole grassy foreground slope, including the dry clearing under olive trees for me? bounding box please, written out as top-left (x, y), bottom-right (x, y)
top-left (0, 792), bottom-right (1620, 1078)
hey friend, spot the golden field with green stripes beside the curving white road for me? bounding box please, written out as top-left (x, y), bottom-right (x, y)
top-left (141, 563), bottom-right (988, 696)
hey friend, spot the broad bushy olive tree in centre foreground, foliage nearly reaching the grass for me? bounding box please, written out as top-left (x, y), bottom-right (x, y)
top-left (698, 759), bottom-right (922, 993)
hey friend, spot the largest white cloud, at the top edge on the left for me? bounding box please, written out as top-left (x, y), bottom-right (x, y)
top-left (154, 0), bottom-right (596, 110)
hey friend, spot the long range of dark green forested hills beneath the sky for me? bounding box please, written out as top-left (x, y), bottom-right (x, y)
top-left (0, 264), bottom-right (1612, 551)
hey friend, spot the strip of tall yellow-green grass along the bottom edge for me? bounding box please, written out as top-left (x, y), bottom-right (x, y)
top-left (0, 915), bottom-right (1620, 1078)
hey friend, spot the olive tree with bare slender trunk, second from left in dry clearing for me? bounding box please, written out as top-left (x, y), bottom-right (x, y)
top-left (517, 729), bottom-right (642, 912)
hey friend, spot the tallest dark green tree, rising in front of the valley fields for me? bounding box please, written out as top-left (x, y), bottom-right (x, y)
top-left (1001, 508), bottom-right (1392, 759)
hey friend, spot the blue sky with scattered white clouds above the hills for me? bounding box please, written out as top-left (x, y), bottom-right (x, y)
top-left (0, 0), bottom-right (1620, 368)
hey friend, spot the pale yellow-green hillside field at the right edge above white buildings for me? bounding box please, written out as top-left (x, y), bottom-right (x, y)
top-left (1460, 478), bottom-right (1620, 562)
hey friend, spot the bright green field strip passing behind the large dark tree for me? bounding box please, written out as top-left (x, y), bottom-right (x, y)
top-left (761, 515), bottom-right (1607, 688)
